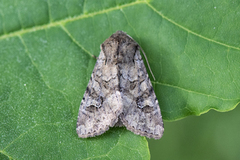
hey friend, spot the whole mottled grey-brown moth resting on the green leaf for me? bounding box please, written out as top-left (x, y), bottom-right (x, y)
top-left (76, 31), bottom-right (164, 139)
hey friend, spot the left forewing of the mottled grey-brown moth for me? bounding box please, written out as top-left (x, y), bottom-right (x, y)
top-left (77, 47), bottom-right (122, 138)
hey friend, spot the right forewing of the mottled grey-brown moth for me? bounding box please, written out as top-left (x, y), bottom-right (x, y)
top-left (120, 51), bottom-right (164, 139)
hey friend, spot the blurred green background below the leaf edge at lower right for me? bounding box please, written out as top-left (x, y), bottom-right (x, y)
top-left (148, 105), bottom-right (240, 160)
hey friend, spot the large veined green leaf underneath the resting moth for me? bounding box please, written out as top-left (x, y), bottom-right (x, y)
top-left (0, 0), bottom-right (240, 159)
